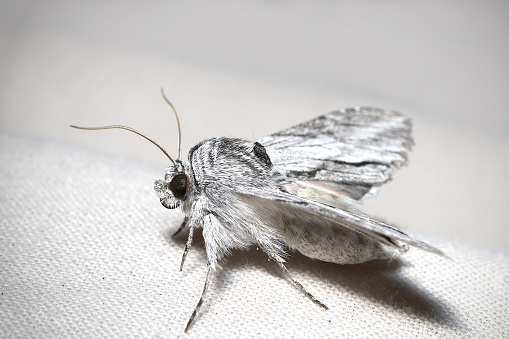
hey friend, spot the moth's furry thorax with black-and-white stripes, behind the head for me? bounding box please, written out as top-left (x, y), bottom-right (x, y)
top-left (189, 137), bottom-right (277, 188)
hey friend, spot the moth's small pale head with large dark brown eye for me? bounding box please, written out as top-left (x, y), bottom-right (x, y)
top-left (154, 159), bottom-right (191, 209)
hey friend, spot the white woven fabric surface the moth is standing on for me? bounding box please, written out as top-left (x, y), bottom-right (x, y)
top-left (0, 131), bottom-right (509, 338)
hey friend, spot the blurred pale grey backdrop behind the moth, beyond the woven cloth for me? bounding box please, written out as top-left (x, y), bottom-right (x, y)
top-left (0, 0), bottom-right (509, 250)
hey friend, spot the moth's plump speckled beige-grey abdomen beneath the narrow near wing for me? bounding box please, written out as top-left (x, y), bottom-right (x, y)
top-left (281, 206), bottom-right (394, 264)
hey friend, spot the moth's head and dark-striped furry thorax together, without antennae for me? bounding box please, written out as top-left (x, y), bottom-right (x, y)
top-left (154, 138), bottom-right (282, 214)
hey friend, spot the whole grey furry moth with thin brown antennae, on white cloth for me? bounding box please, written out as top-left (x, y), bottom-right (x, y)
top-left (71, 90), bottom-right (443, 331)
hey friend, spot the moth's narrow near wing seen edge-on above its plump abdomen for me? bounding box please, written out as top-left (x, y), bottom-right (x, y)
top-left (231, 185), bottom-right (444, 255)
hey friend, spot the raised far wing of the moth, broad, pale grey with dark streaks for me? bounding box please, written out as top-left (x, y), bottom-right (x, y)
top-left (258, 107), bottom-right (413, 200)
